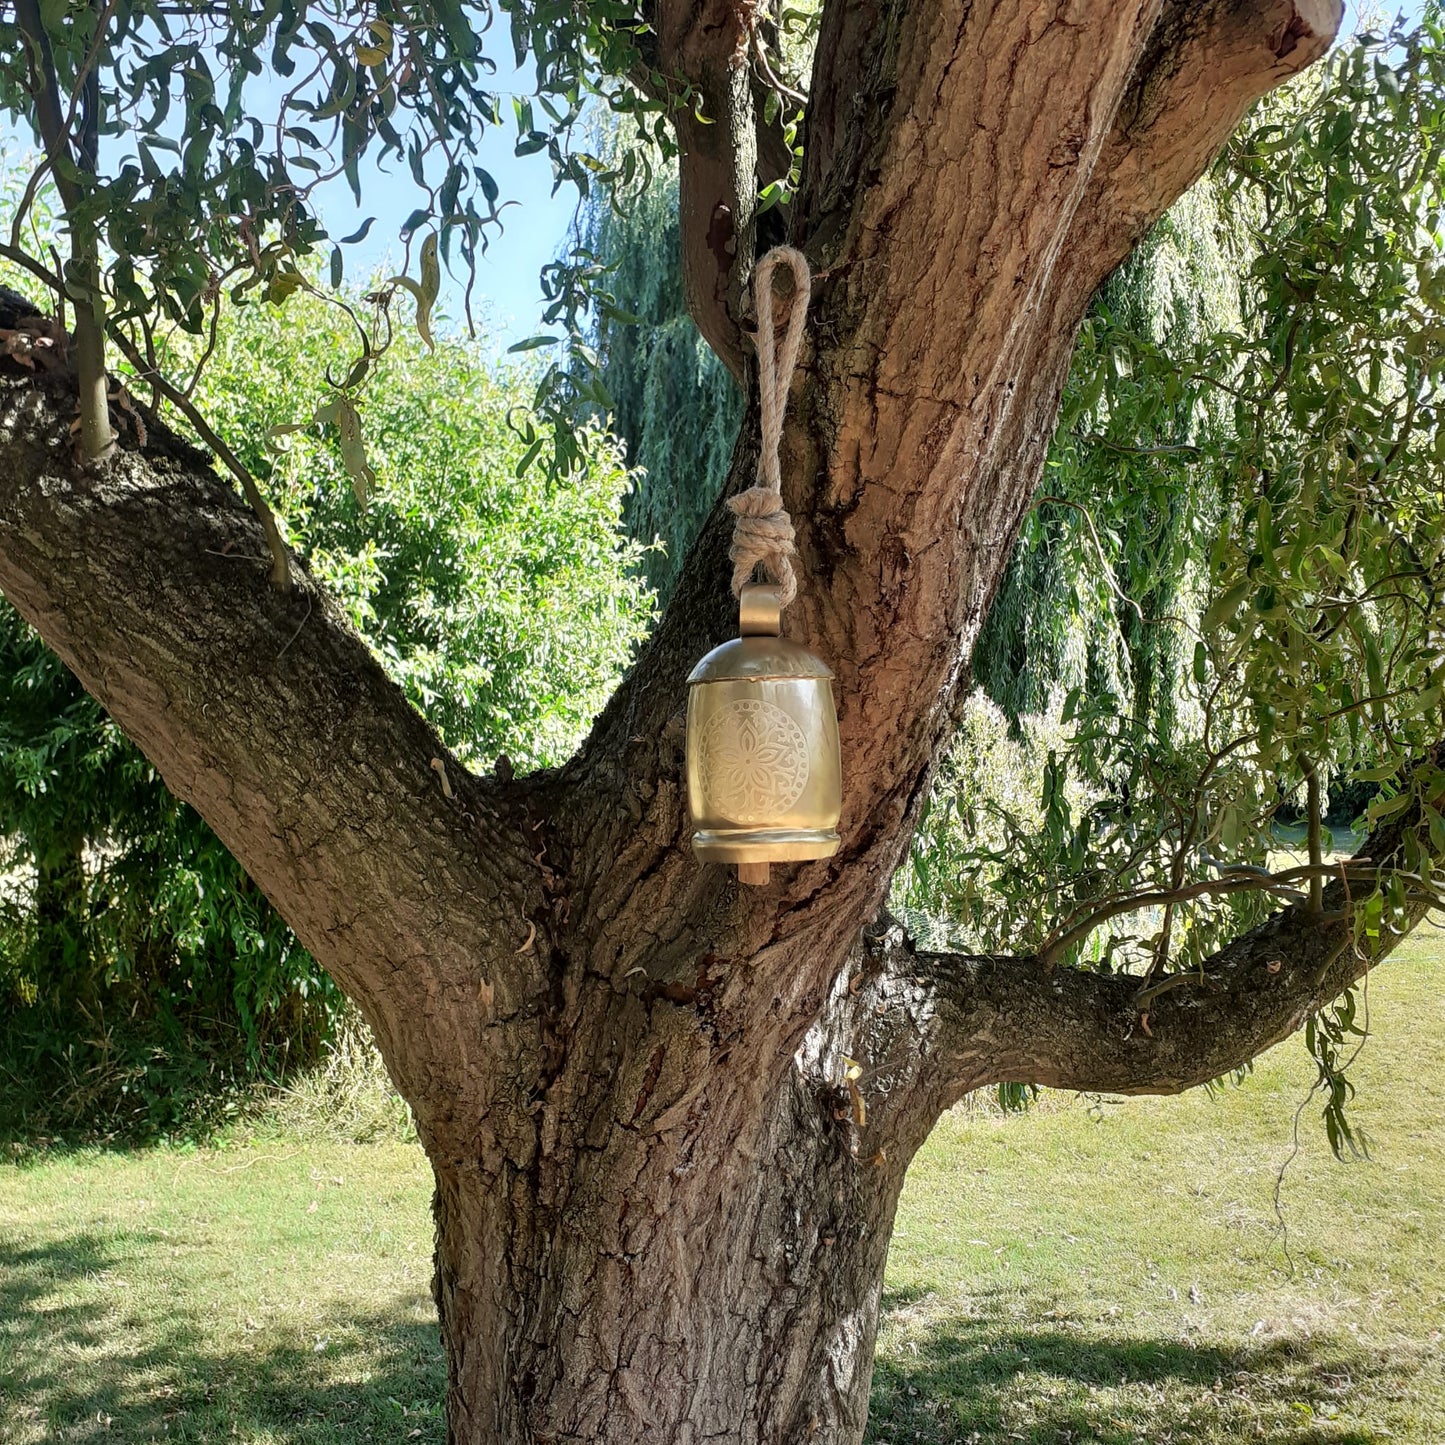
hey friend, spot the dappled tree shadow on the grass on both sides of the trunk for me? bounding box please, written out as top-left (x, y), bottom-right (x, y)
top-left (0, 1231), bottom-right (1398, 1445)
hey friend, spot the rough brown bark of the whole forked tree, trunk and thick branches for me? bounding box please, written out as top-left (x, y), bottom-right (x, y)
top-left (0, 0), bottom-right (1364, 1445)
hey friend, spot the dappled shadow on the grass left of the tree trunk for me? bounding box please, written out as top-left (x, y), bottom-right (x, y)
top-left (0, 1233), bottom-right (447, 1445)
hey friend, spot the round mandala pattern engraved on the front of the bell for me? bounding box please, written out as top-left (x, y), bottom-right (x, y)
top-left (702, 698), bottom-right (808, 824)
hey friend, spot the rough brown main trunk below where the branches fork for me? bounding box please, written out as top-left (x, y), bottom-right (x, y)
top-left (421, 1005), bottom-right (903, 1445)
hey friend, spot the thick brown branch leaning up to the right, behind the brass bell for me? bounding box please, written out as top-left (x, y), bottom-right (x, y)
top-left (549, 0), bottom-right (1340, 1103)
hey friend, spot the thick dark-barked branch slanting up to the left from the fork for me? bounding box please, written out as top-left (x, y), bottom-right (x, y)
top-left (0, 383), bottom-right (552, 1136)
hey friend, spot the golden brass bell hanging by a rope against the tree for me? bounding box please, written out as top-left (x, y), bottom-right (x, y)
top-left (688, 582), bottom-right (842, 883)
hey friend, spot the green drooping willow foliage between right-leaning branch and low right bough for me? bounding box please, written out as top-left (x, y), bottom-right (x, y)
top-left (900, 17), bottom-right (1445, 999)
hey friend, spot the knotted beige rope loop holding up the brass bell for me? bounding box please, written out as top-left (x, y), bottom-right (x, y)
top-left (728, 246), bottom-right (812, 607)
